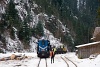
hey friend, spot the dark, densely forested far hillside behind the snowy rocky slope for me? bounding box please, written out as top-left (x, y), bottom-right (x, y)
top-left (33, 0), bottom-right (98, 49)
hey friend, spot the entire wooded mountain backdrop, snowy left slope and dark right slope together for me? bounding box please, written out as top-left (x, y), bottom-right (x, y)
top-left (0, 0), bottom-right (100, 50)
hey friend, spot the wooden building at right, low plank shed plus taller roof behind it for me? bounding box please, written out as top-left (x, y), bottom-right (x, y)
top-left (76, 27), bottom-right (100, 58)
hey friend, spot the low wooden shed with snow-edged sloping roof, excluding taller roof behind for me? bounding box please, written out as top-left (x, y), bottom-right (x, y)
top-left (76, 41), bottom-right (100, 58)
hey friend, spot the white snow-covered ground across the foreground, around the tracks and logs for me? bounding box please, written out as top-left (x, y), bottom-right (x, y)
top-left (0, 53), bottom-right (100, 67)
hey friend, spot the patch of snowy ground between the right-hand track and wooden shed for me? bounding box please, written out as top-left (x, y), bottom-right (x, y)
top-left (66, 53), bottom-right (100, 67)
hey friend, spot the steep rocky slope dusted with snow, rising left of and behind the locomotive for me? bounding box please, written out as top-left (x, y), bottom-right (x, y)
top-left (0, 0), bottom-right (71, 52)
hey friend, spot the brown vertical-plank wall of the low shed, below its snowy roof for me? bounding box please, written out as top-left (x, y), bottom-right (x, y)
top-left (78, 44), bottom-right (100, 58)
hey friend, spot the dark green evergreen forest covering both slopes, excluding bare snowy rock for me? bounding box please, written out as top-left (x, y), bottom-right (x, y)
top-left (0, 0), bottom-right (100, 50)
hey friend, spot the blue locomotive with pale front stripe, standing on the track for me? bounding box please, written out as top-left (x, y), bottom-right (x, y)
top-left (37, 39), bottom-right (51, 58)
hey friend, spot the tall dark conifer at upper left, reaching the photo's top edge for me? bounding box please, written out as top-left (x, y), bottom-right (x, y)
top-left (5, 0), bottom-right (20, 28)
